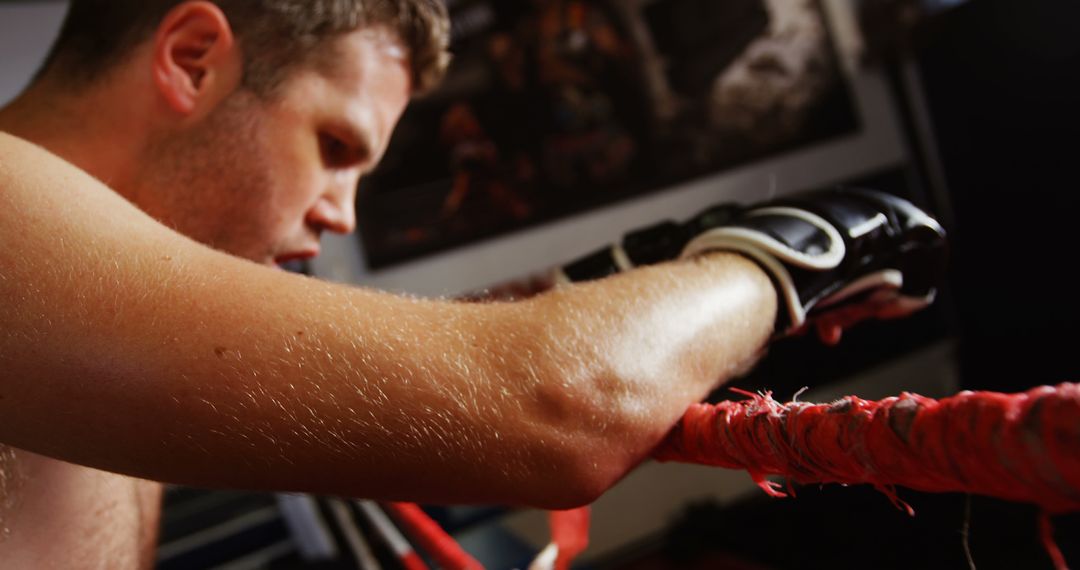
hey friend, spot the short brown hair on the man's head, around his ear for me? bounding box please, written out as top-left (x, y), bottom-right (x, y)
top-left (42, 0), bottom-right (449, 95)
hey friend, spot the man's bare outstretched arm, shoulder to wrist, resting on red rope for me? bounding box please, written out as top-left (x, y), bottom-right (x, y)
top-left (0, 135), bottom-right (777, 506)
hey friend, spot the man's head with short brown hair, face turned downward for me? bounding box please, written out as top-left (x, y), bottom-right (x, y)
top-left (29, 0), bottom-right (448, 263)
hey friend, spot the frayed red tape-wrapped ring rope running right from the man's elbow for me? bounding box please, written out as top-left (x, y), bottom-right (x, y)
top-left (654, 383), bottom-right (1080, 514)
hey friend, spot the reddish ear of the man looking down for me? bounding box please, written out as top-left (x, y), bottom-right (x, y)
top-left (153, 1), bottom-right (242, 116)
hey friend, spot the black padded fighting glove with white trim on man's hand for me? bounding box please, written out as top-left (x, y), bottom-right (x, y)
top-left (563, 190), bottom-right (945, 336)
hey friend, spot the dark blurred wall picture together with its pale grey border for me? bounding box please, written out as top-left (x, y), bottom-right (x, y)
top-left (315, 0), bottom-right (903, 295)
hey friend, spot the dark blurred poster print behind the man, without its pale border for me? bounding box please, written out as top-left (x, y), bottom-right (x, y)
top-left (357, 0), bottom-right (859, 269)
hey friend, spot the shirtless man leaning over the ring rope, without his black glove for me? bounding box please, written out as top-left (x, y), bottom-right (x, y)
top-left (0, 0), bottom-right (946, 569)
